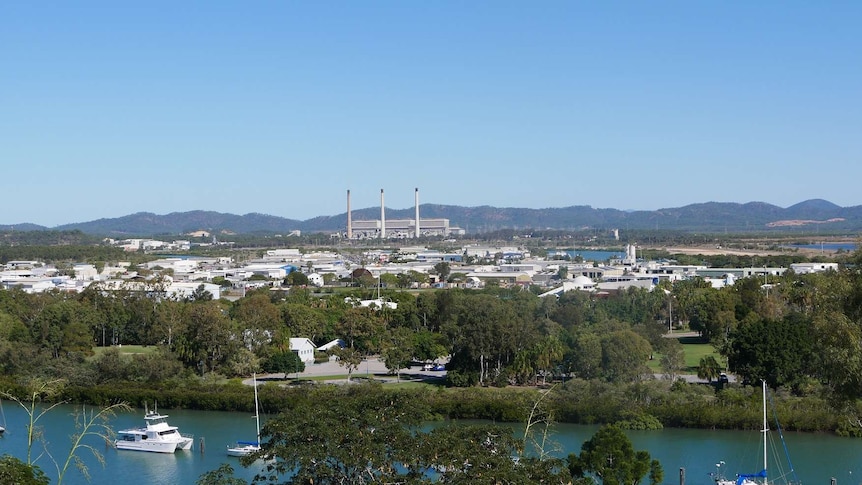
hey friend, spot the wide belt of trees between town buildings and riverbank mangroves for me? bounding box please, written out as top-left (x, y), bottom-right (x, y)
top-left (0, 246), bottom-right (862, 434)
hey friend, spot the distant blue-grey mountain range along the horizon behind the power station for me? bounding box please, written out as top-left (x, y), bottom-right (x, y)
top-left (0, 199), bottom-right (862, 237)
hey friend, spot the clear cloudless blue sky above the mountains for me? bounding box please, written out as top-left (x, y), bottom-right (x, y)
top-left (0, 0), bottom-right (862, 226)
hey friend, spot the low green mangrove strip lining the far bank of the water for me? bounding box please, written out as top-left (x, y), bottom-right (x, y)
top-left (5, 378), bottom-right (862, 437)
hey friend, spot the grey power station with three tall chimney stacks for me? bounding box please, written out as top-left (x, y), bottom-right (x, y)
top-left (347, 188), bottom-right (450, 239)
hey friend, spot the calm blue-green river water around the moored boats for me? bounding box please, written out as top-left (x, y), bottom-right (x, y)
top-left (0, 402), bottom-right (862, 485)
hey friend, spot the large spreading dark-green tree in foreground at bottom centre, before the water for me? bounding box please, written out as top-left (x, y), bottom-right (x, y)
top-left (253, 385), bottom-right (569, 485)
